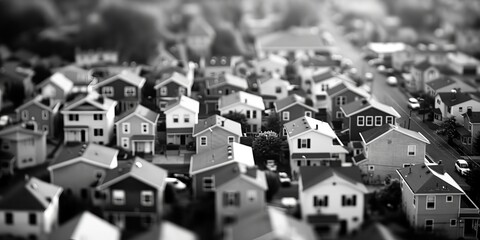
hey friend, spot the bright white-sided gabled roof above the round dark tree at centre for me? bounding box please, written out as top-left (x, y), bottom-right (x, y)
top-left (218, 91), bottom-right (265, 111)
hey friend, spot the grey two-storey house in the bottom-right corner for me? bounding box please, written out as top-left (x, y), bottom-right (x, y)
top-left (397, 164), bottom-right (480, 239)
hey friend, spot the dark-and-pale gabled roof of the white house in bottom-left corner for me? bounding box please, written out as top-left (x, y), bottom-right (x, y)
top-left (0, 177), bottom-right (63, 211)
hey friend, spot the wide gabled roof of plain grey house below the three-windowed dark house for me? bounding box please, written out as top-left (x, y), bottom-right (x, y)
top-left (360, 124), bottom-right (430, 144)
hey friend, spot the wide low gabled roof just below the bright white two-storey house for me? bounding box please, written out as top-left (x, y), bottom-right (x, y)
top-left (48, 143), bottom-right (118, 171)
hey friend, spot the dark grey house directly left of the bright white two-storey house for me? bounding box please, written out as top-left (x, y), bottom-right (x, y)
top-left (15, 95), bottom-right (61, 138)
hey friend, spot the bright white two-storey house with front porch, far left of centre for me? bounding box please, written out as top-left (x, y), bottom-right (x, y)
top-left (61, 92), bottom-right (117, 144)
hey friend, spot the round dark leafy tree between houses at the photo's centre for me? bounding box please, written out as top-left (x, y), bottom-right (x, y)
top-left (252, 131), bottom-right (282, 164)
